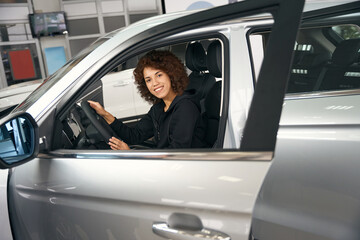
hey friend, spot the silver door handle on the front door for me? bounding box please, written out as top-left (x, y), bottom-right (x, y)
top-left (152, 213), bottom-right (231, 240)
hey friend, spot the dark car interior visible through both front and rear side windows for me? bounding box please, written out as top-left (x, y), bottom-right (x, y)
top-left (52, 21), bottom-right (360, 152)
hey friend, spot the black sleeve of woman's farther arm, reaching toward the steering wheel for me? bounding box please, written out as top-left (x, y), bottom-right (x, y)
top-left (110, 110), bottom-right (154, 144)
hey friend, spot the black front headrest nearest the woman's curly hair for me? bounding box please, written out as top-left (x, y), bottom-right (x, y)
top-left (185, 42), bottom-right (207, 72)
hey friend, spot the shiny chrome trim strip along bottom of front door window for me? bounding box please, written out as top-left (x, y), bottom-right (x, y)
top-left (38, 149), bottom-right (273, 161)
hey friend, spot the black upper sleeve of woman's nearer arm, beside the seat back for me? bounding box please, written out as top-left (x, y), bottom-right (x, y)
top-left (169, 100), bottom-right (200, 148)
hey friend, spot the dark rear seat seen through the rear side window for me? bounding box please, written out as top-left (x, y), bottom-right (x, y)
top-left (318, 39), bottom-right (360, 91)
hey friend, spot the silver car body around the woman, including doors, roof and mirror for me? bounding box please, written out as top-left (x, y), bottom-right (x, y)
top-left (0, 0), bottom-right (360, 240)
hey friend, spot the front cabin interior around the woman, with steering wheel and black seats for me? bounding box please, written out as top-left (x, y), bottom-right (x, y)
top-left (52, 39), bottom-right (222, 150)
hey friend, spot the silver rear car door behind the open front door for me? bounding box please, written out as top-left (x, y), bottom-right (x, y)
top-left (251, 1), bottom-right (360, 240)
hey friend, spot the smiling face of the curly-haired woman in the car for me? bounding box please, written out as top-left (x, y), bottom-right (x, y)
top-left (143, 67), bottom-right (176, 100)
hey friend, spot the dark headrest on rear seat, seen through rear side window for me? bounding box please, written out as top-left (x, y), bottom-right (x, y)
top-left (332, 39), bottom-right (360, 66)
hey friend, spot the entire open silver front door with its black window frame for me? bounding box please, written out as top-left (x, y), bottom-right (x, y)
top-left (4, 0), bottom-right (303, 240)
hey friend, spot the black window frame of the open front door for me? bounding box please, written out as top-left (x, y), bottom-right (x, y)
top-left (40, 0), bottom-right (303, 158)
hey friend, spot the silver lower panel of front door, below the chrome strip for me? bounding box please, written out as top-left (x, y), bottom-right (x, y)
top-left (10, 152), bottom-right (271, 239)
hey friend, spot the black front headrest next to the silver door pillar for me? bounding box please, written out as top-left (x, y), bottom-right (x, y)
top-left (206, 40), bottom-right (222, 78)
